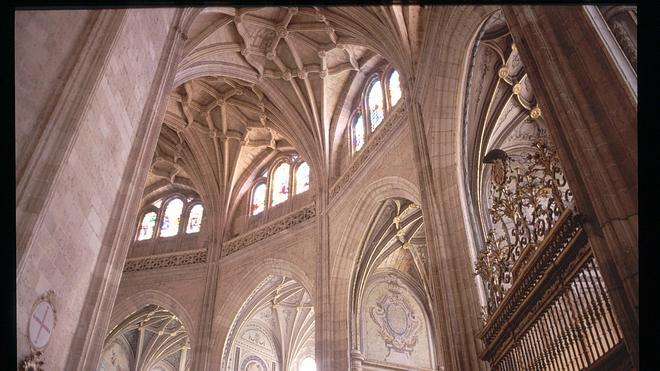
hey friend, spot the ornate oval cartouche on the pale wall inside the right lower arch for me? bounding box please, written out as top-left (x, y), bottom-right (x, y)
top-left (370, 278), bottom-right (421, 356)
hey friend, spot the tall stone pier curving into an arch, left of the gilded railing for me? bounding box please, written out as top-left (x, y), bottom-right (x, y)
top-left (403, 6), bottom-right (498, 370)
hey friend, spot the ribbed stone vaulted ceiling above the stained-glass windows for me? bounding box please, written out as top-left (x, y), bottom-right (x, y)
top-left (144, 6), bottom-right (422, 234)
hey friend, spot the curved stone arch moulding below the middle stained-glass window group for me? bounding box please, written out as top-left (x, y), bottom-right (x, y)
top-left (208, 258), bottom-right (316, 370)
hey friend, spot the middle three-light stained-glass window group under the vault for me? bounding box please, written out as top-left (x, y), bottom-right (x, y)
top-left (249, 154), bottom-right (310, 215)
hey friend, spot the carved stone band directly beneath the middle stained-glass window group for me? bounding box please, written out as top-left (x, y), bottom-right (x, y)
top-left (220, 203), bottom-right (316, 257)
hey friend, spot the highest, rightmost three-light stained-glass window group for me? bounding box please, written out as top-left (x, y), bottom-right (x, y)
top-left (350, 68), bottom-right (402, 153)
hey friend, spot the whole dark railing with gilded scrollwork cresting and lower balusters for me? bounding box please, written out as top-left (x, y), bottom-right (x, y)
top-left (475, 142), bottom-right (626, 370)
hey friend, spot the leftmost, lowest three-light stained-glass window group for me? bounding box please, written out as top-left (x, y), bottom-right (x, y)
top-left (137, 195), bottom-right (204, 241)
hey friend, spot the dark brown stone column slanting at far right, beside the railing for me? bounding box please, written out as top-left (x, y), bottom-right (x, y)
top-left (503, 6), bottom-right (639, 368)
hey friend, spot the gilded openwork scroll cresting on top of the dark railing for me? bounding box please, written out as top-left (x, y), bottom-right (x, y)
top-left (475, 139), bottom-right (572, 316)
